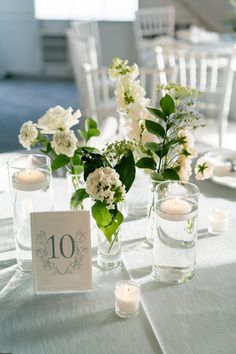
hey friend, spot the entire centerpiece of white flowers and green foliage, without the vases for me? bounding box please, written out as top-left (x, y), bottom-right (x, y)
top-left (19, 58), bottom-right (212, 258)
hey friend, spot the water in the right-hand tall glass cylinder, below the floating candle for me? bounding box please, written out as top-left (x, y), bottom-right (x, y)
top-left (153, 200), bottom-right (197, 284)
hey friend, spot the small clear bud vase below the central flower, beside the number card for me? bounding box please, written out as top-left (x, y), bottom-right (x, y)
top-left (97, 228), bottom-right (122, 270)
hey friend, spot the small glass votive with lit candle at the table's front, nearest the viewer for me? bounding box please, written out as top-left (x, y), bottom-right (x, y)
top-left (115, 280), bottom-right (140, 318)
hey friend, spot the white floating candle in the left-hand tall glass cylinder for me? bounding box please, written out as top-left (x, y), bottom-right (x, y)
top-left (12, 170), bottom-right (47, 191)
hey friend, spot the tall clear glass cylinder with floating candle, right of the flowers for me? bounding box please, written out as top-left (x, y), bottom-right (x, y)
top-left (153, 181), bottom-right (199, 284)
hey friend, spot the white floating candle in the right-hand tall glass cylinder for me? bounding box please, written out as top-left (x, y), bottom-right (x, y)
top-left (159, 198), bottom-right (192, 221)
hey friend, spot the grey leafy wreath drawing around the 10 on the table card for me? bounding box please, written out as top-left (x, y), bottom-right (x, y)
top-left (35, 230), bottom-right (88, 275)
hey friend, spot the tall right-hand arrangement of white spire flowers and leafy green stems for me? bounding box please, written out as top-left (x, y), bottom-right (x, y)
top-left (108, 58), bottom-right (212, 182)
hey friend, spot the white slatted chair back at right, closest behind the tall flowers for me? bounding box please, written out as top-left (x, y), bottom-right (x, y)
top-left (156, 47), bottom-right (235, 146)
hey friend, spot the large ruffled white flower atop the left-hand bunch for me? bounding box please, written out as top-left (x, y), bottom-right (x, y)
top-left (38, 106), bottom-right (81, 134)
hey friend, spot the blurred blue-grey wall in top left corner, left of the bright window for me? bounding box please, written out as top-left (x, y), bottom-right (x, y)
top-left (0, 0), bottom-right (41, 75)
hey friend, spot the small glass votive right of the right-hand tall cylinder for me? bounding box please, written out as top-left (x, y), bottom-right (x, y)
top-left (208, 209), bottom-right (229, 234)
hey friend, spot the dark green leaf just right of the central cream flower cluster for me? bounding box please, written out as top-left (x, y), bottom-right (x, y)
top-left (114, 151), bottom-right (135, 192)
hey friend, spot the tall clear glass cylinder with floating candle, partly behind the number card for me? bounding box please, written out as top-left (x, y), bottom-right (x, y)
top-left (8, 154), bottom-right (53, 271)
